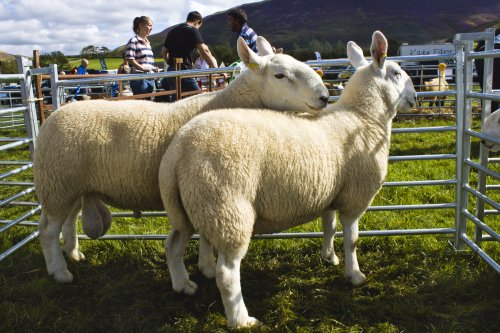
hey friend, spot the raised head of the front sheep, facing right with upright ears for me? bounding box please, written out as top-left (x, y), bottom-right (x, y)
top-left (346, 31), bottom-right (416, 119)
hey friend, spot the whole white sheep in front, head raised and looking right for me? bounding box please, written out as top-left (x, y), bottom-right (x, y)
top-left (159, 31), bottom-right (416, 327)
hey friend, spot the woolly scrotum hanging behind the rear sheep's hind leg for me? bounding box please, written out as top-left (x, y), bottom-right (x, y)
top-left (82, 195), bottom-right (111, 239)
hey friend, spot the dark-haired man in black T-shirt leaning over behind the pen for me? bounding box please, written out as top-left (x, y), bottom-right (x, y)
top-left (161, 11), bottom-right (217, 100)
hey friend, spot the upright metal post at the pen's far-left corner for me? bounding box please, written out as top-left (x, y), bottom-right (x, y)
top-left (16, 56), bottom-right (38, 160)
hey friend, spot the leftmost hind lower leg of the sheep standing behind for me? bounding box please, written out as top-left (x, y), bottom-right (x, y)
top-left (38, 211), bottom-right (73, 283)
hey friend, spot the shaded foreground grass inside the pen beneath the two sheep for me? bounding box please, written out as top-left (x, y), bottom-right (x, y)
top-left (0, 238), bottom-right (500, 332)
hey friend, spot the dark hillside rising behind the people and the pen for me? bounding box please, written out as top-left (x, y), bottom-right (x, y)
top-left (151, 0), bottom-right (500, 57)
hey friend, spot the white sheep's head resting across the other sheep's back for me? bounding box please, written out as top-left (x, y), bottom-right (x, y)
top-left (238, 36), bottom-right (328, 114)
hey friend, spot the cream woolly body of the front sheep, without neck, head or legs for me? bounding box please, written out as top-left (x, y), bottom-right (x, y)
top-left (168, 110), bottom-right (388, 237)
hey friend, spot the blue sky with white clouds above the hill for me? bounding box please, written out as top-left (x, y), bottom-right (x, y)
top-left (0, 0), bottom-right (257, 56)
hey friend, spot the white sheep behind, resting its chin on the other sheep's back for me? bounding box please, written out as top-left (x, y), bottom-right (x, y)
top-left (34, 38), bottom-right (328, 282)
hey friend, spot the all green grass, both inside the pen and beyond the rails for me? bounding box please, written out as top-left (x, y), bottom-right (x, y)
top-left (0, 118), bottom-right (500, 332)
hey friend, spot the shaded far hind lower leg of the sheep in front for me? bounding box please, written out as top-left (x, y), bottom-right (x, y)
top-left (165, 229), bottom-right (198, 295)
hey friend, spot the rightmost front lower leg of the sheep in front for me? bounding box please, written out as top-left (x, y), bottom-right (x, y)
top-left (340, 216), bottom-right (366, 286)
